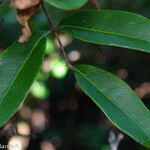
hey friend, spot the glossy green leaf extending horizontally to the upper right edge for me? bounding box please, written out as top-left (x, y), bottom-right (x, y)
top-left (59, 10), bottom-right (150, 53)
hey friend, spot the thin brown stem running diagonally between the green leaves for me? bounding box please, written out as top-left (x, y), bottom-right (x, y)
top-left (41, 3), bottom-right (73, 70)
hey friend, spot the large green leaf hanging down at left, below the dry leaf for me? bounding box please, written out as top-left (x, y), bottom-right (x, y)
top-left (0, 32), bottom-right (46, 126)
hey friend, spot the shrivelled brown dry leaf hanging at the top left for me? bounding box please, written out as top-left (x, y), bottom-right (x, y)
top-left (11, 0), bottom-right (42, 43)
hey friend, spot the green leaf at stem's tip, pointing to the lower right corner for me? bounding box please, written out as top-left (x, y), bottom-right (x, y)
top-left (74, 65), bottom-right (150, 148)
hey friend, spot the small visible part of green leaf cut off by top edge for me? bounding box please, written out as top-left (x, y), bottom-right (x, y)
top-left (45, 0), bottom-right (88, 10)
